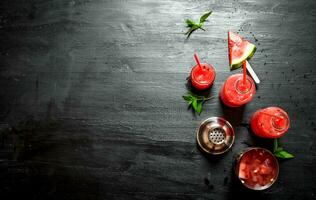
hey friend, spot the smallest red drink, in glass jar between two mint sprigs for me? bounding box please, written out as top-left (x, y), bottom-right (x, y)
top-left (190, 63), bottom-right (215, 90)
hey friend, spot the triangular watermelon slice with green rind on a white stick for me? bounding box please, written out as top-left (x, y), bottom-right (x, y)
top-left (228, 31), bottom-right (257, 70)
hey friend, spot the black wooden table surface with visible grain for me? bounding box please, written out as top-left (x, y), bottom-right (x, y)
top-left (0, 0), bottom-right (316, 200)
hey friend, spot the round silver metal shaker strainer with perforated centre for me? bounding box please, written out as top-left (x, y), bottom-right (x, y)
top-left (197, 117), bottom-right (235, 155)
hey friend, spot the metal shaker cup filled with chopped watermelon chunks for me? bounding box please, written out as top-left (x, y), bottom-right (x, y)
top-left (235, 147), bottom-right (279, 190)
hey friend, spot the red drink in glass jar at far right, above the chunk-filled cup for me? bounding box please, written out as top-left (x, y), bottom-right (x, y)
top-left (250, 107), bottom-right (290, 138)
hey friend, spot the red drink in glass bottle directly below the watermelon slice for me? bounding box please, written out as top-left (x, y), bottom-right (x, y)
top-left (220, 74), bottom-right (256, 107)
